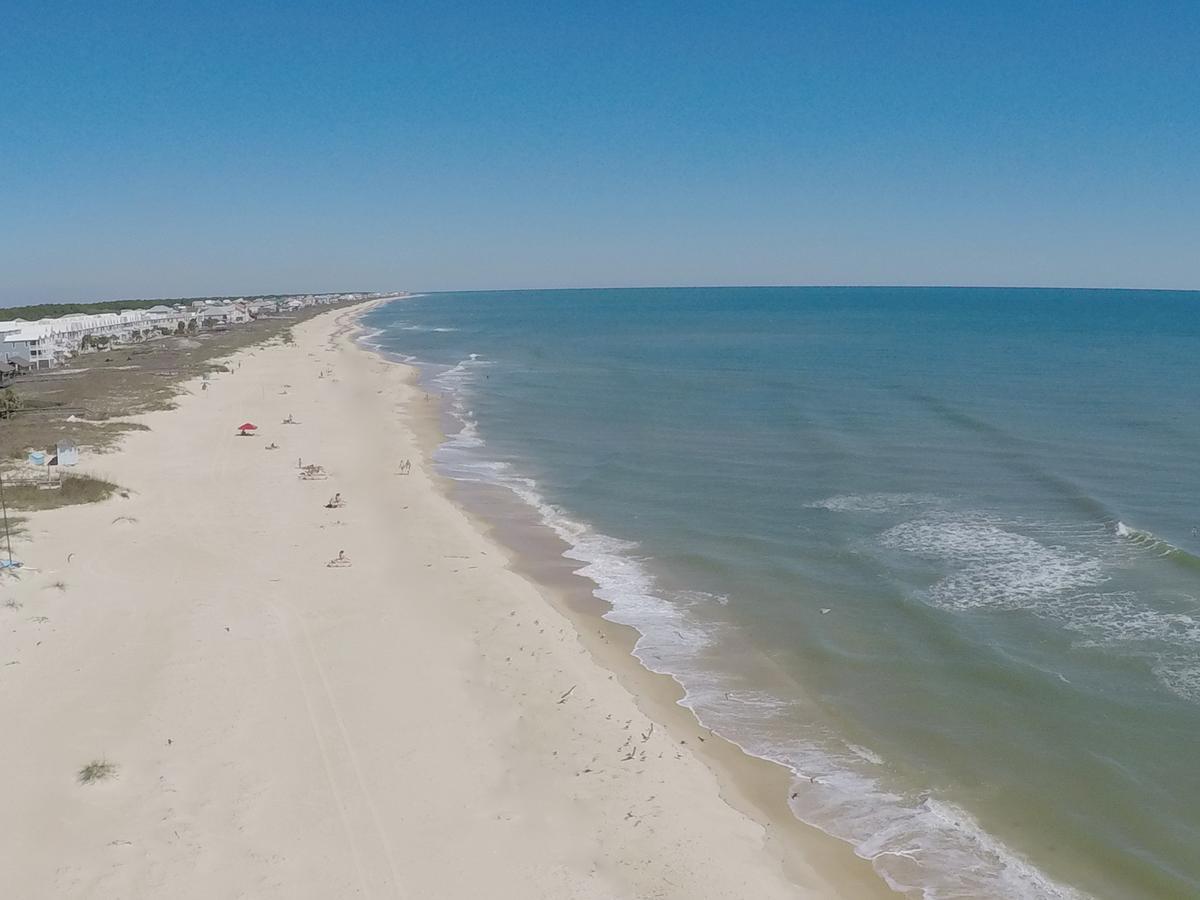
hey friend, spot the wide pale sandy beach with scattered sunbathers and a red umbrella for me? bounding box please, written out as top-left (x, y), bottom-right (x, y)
top-left (0, 304), bottom-right (884, 900)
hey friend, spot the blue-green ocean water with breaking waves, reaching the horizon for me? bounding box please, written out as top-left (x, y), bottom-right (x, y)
top-left (365, 288), bottom-right (1200, 899)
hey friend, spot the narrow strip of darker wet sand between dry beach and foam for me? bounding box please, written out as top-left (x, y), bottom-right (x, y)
top-left (352, 304), bottom-right (900, 900)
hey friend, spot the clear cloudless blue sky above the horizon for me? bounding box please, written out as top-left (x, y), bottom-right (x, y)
top-left (0, 0), bottom-right (1200, 304)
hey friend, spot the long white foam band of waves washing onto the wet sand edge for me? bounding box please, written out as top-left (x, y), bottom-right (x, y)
top-left (405, 355), bottom-right (1078, 900)
